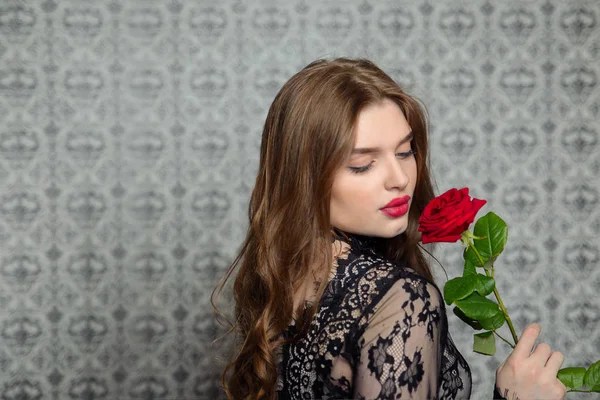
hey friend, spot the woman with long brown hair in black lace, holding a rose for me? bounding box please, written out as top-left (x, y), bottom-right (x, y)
top-left (213, 58), bottom-right (565, 399)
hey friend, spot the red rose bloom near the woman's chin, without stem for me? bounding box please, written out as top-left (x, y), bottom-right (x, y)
top-left (419, 188), bottom-right (486, 243)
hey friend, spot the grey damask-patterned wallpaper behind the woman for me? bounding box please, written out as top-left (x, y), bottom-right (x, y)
top-left (0, 0), bottom-right (600, 400)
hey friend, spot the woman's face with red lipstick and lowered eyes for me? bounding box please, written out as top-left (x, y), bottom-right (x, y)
top-left (331, 99), bottom-right (417, 238)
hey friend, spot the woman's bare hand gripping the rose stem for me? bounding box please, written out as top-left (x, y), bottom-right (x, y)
top-left (496, 323), bottom-right (567, 400)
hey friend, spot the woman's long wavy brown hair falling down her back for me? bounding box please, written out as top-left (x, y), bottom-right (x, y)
top-left (211, 58), bottom-right (434, 400)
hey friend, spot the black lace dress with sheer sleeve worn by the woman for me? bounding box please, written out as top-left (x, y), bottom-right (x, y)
top-left (277, 234), bottom-right (471, 399)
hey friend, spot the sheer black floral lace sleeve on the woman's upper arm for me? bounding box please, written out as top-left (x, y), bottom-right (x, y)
top-left (354, 278), bottom-right (443, 399)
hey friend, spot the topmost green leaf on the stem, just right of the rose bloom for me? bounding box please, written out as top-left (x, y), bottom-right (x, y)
top-left (473, 211), bottom-right (508, 261)
